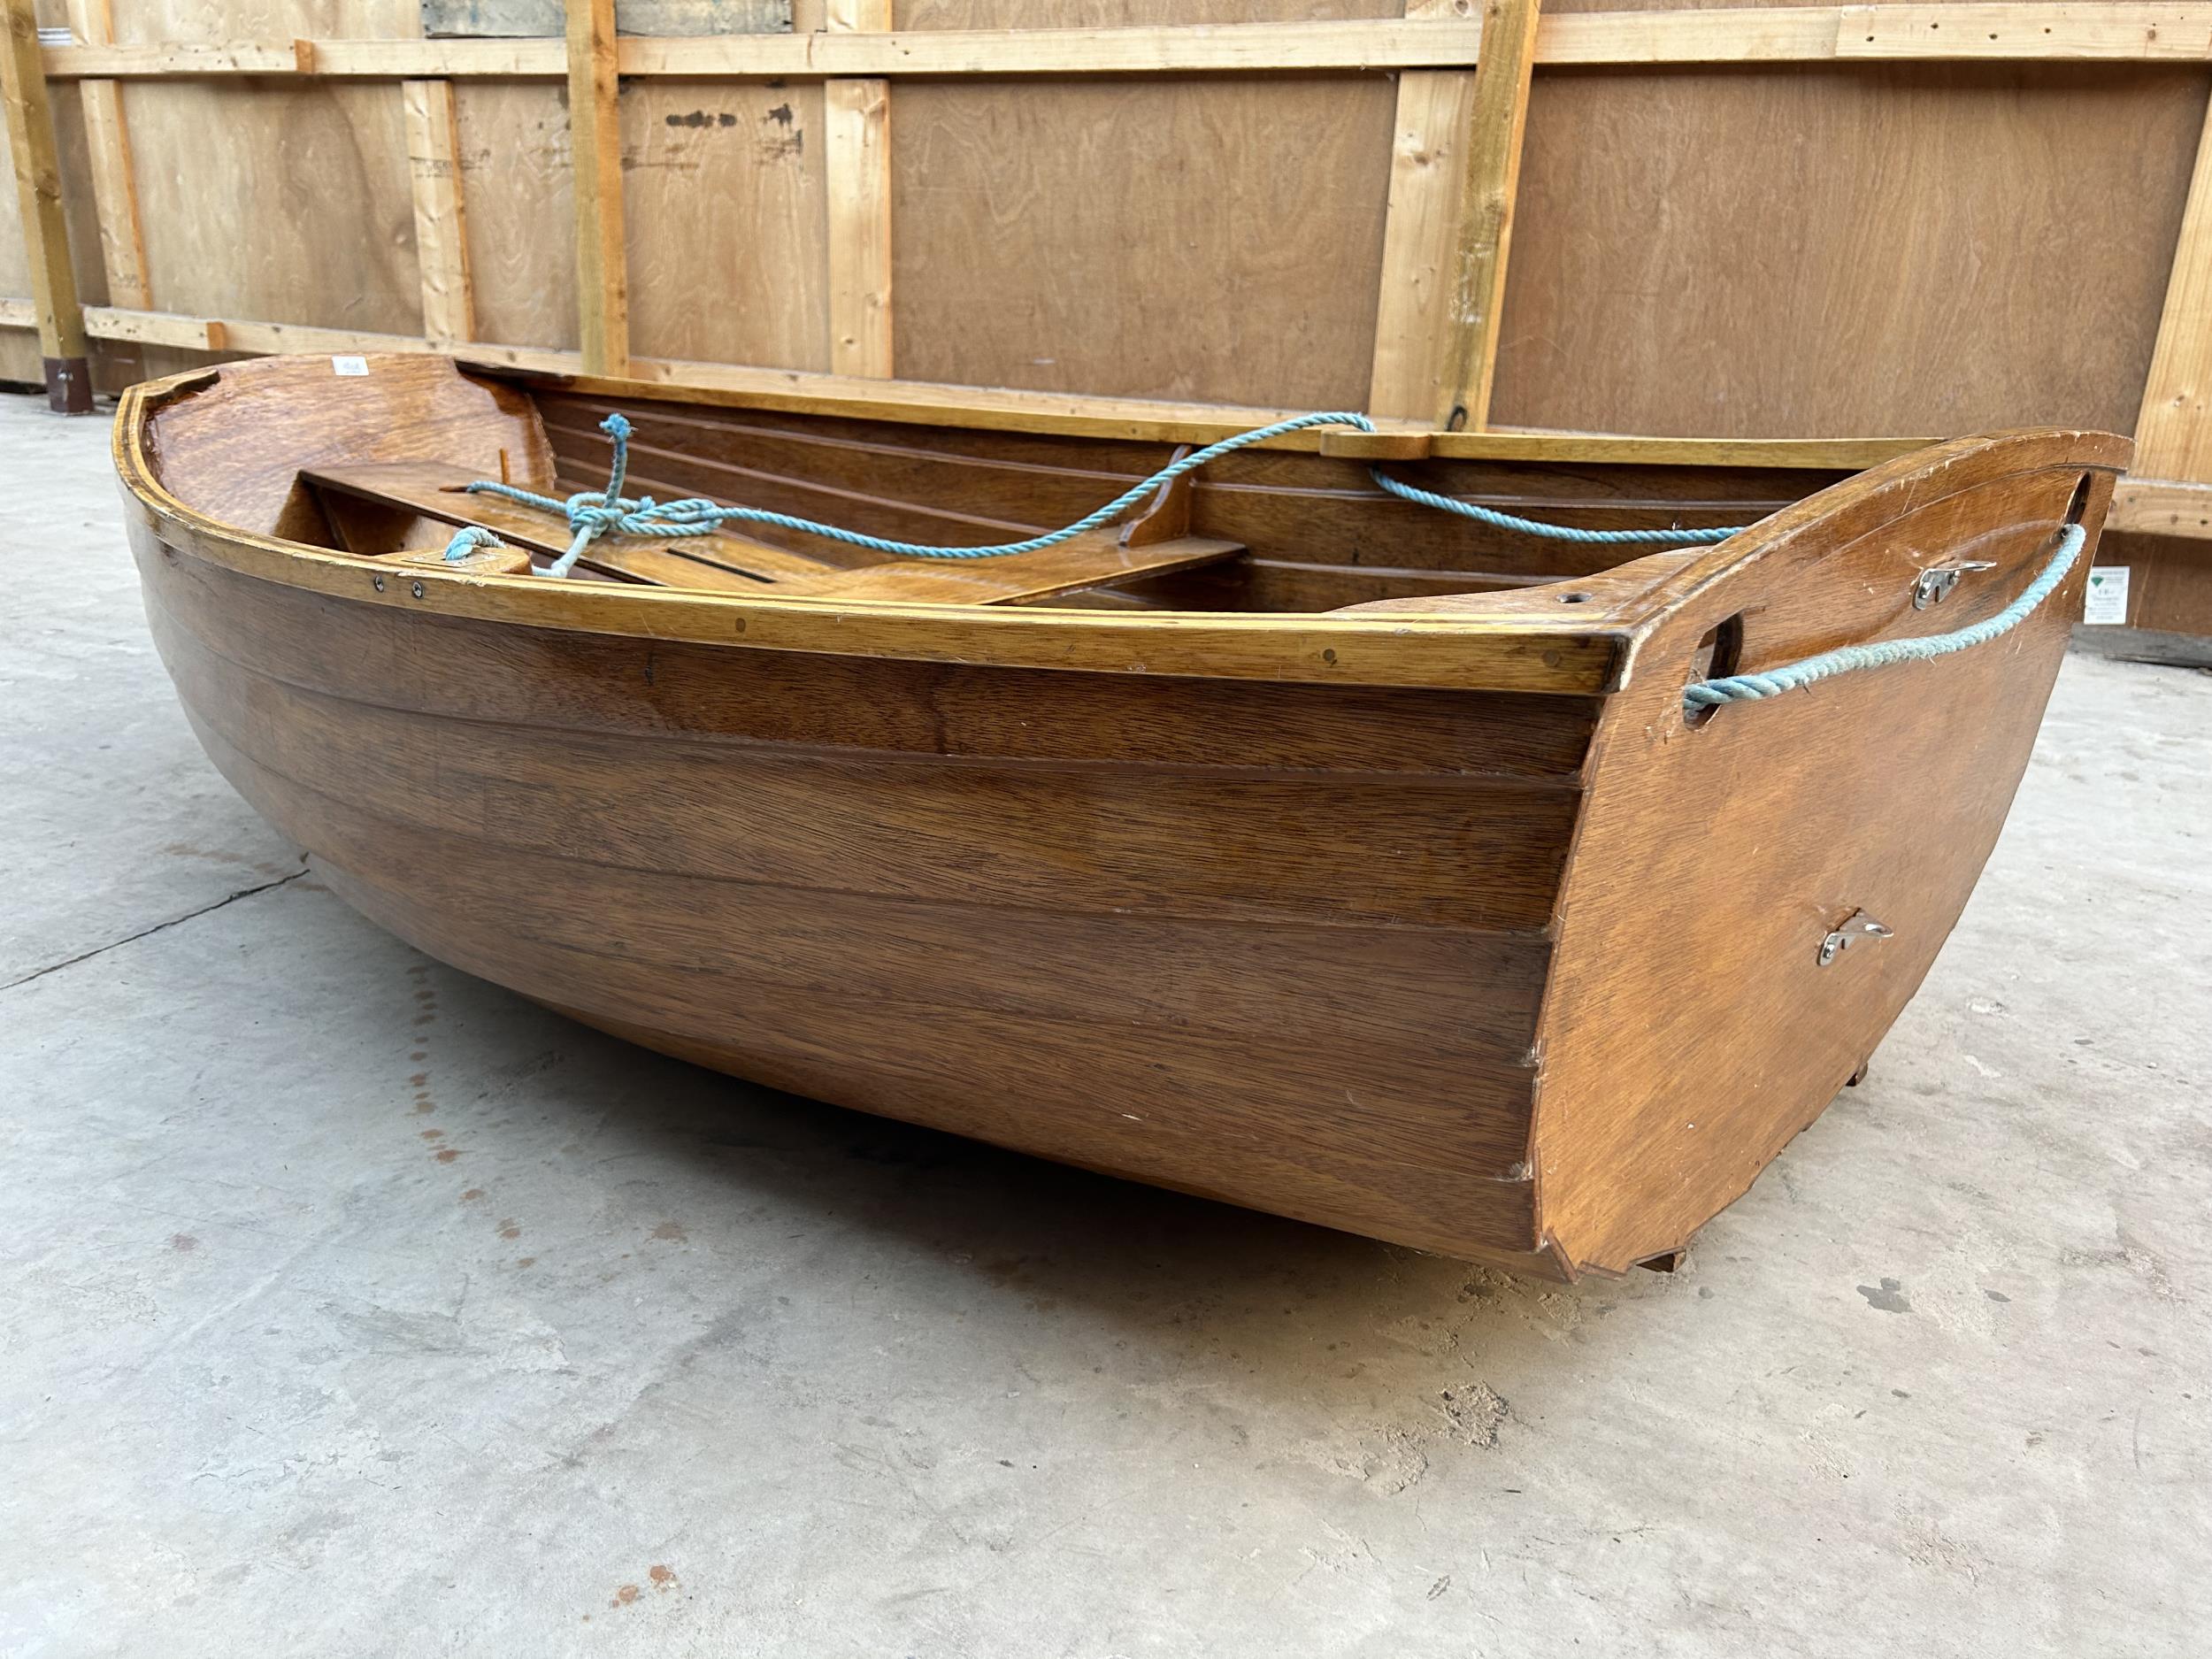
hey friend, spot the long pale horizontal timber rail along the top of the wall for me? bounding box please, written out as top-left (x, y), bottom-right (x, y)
top-left (44, 0), bottom-right (2212, 80)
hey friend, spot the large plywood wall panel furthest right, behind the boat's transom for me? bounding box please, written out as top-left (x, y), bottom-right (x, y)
top-left (1494, 65), bottom-right (2206, 438)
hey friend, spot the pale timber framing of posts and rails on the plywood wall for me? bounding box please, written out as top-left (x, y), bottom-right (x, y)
top-left (12, 0), bottom-right (2212, 538)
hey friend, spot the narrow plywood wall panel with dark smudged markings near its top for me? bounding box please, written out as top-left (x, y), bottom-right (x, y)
top-left (622, 80), bottom-right (830, 370)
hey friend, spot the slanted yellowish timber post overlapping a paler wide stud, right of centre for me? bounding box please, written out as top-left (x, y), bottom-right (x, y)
top-left (1436, 0), bottom-right (1540, 432)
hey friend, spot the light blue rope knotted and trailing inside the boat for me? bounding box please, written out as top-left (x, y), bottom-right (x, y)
top-left (462, 411), bottom-right (1743, 575)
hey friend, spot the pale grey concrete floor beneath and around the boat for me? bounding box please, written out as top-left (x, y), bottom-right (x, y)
top-left (0, 382), bottom-right (2212, 1659)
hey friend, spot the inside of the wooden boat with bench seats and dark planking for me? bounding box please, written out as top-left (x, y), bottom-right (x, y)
top-left (237, 370), bottom-right (1852, 613)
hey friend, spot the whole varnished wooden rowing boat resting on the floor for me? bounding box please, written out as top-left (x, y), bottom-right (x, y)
top-left (115, 357), bottom-right (2128, 1277)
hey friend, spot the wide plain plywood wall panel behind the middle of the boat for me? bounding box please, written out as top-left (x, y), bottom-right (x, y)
top-left (892, 75), bottom-right (1396, 407)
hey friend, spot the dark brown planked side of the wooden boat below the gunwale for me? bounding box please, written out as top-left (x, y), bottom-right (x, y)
top-left (140, 531), bottom-right (1597, 1265)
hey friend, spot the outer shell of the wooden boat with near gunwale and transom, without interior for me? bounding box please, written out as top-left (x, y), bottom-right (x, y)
top-left (118, 354), bottom-right (2128, 1279)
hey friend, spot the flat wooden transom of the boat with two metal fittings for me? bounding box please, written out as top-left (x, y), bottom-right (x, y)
top-left (1535, 434), bottom-right (2126, 1272)
